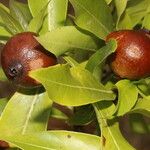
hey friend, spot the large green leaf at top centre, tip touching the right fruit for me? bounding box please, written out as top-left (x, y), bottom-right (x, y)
top-left (70, 0), bottom-right (114, 39)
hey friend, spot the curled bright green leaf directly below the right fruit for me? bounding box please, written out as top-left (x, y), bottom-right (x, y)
top-left (115, 80), bottom-right (138, 116)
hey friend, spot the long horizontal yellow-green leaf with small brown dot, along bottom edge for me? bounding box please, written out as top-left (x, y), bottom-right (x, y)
top-left (6, 131), bottom-right (100, 150)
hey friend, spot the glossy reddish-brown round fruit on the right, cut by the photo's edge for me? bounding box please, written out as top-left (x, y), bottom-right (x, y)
top-left (106, 30), bottom-right (150, 79)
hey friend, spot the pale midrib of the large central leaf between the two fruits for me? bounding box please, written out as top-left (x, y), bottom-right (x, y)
top-left (39, 79), bottom-right (113, 94)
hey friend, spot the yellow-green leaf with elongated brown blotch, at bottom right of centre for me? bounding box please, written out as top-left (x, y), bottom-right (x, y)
top-left (94, 101), bottom-right (135, 150)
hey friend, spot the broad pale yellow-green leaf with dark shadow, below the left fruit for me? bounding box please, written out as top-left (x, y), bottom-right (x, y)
top-left (0, 93), bottom-right (52, 138)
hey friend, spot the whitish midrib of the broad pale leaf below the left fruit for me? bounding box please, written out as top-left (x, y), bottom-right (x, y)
top-left (22, 94), bottom-right (38, 134)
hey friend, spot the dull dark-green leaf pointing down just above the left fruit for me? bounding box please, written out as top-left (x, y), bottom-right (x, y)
top-left (9, 0), bottom-right (32, 31)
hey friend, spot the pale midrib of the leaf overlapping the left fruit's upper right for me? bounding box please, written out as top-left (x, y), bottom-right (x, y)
top-left (38, 41), bottom-right (96, 52)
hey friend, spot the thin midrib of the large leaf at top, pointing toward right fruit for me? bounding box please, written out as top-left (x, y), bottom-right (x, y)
top-left (76, 1), bottom-right (110, 33)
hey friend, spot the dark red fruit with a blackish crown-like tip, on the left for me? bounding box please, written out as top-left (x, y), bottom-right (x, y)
top-left (1, 32), bottom-right (56, 87)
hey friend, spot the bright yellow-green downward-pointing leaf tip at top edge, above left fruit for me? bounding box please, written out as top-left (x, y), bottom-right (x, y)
top-left (28, 0), bottom-right (51, 17)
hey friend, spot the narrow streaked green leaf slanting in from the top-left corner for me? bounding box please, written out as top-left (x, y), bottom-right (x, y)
top-left (0, 4), bottom-right (23, 34)
